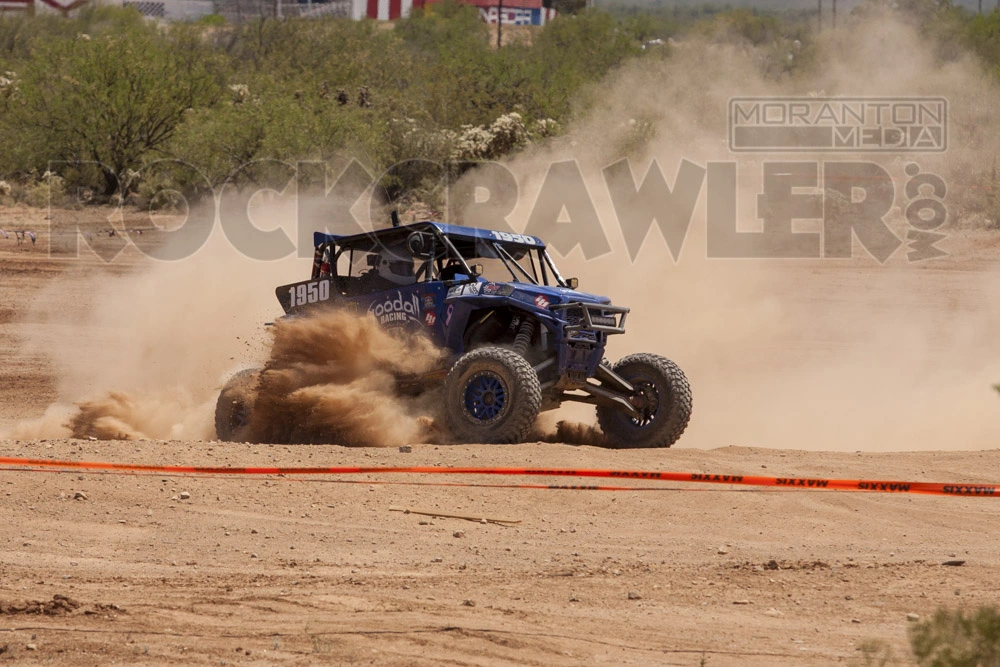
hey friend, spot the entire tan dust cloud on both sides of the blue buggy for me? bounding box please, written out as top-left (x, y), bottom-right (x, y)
top-left (8, 17), bottom-right (1000, 451)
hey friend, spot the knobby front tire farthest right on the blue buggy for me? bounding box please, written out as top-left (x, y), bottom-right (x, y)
top-left (597, 354), bottom-right (692, 449)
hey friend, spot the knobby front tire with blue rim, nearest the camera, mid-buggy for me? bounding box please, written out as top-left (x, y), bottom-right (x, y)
top-left (444, 347), bottom-right (542, 443)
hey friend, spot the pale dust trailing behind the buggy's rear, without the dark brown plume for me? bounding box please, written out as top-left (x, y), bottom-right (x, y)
top-left (6, 202), bottom-right (296, 439)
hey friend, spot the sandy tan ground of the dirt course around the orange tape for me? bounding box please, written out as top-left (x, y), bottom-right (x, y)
top-left (0, 207), bottom-right (1000, 665)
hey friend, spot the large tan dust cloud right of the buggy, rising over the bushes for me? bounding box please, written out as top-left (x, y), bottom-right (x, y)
top-left (464, 17), bottom-right (1000, 451)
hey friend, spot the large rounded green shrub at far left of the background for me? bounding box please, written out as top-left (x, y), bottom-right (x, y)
top-left (0, 18), bottom-right (218, 196)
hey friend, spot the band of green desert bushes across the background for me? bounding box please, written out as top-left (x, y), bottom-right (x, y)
top-left (0, 0), bottom-right (1000, 211)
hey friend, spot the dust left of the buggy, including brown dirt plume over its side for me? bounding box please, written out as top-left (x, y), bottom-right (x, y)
top-left (3, 190), bottom-right (452, 446)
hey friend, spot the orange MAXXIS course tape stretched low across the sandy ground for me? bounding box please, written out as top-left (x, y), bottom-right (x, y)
top-left (0, 457), bottom-right (1000, 498)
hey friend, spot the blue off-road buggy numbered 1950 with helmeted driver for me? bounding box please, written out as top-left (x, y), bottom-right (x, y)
top-left (216, 222), bottom-right (691, 447)
